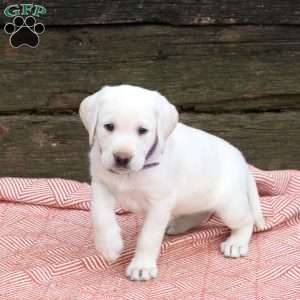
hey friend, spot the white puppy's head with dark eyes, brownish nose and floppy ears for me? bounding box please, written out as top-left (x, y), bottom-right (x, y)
top-left (79, 85), bottom-right (178, 173)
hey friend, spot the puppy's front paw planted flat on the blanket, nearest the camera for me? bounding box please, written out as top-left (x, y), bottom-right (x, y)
top-left (126, 258), bottom-right (157, 280)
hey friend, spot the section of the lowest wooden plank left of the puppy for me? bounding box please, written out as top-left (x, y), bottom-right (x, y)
top-left (0, 115), bottom-right (88, 180)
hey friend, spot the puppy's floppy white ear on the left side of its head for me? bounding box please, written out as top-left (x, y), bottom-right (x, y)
top-left (79, 87), bottom-right (106, 146)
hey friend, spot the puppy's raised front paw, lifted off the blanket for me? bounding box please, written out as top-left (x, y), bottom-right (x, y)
top-left (95, 235), bottom-right (123, 262)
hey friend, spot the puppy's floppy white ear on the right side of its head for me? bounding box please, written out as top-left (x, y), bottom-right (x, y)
top-left (154, 92), bottom-right (178, 151)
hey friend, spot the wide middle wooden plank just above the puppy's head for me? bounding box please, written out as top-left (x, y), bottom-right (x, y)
top-left (0, 25), bottom-right (300, 113)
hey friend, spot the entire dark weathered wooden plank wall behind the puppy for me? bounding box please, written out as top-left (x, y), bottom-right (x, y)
top-left (0, 0), bottom-right (300, 181)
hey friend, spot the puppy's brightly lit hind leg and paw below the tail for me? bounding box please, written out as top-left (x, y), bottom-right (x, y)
top-left (217, 193), bottom-right (254, 258)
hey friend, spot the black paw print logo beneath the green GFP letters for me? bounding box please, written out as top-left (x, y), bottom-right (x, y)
top-left (4, 16), bottom-right (45, 48)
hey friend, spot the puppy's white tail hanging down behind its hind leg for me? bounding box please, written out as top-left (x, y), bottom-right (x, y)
top-left (248, 174), bottom-right (265, 229)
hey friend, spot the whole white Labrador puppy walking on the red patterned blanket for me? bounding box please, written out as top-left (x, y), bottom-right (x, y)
top-left (79, 85), bottom-right (264, 280)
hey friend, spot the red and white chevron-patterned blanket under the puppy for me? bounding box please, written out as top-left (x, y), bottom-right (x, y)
top-left (0, 166), bottom-right (300, 300)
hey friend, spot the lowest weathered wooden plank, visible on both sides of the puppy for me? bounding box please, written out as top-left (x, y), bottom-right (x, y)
top-left (0, 112), bottom-right (300, 181)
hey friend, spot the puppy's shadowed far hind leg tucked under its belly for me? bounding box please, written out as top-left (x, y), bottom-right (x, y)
top-left (166, 212), bottom-right (211, 235)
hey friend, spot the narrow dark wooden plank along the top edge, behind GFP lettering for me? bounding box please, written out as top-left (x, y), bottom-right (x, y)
top-left (0, 0), bottom-right (300, 25)
